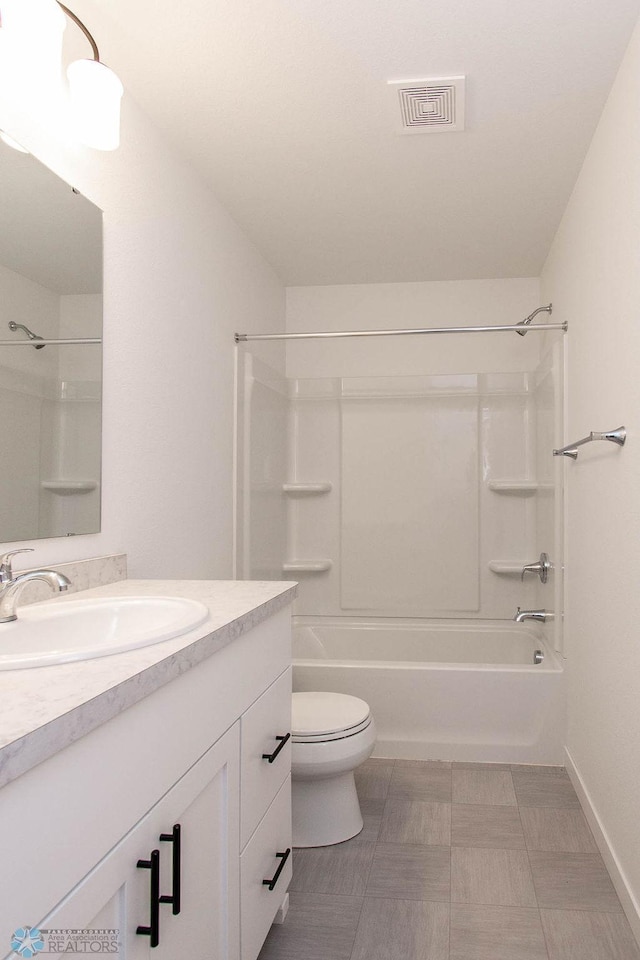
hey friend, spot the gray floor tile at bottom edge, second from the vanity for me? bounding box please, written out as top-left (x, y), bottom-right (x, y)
top-left (348, 898), bottom-right (449, 960)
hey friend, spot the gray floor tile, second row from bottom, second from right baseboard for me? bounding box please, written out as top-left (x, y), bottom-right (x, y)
top-left (451, 847), bottom-right (537, 907)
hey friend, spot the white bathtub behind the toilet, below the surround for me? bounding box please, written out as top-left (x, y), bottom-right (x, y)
top-left (293, 617), bottom-right (564, 764)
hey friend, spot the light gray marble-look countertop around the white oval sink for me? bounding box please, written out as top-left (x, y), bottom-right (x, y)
top-left (0, 580), bottom-right (296, 786)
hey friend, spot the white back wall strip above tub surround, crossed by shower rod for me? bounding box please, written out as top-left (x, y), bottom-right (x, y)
top-left (287, 278), bottom-right (549, 377)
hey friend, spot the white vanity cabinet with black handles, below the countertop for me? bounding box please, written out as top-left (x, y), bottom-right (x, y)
top-left (0, 608), bottom-right (291, 960)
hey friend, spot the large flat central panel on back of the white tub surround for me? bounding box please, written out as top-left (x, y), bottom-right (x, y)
top-left (340, 396), bottom-right (480, 617)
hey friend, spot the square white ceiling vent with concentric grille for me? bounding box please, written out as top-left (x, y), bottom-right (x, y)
top-left (388, 77), bottom-right (464, 133)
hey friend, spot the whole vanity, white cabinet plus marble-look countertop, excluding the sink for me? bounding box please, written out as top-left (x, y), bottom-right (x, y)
top-left (0, 581), bottom-right (295, 960)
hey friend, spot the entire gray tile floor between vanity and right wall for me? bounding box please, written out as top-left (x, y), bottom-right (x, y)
top-left (259, 760), bottom-right (640, 960)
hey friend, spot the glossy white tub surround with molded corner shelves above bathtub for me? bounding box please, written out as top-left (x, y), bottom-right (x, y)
top-left (237, 360), bottom-right (561, 634)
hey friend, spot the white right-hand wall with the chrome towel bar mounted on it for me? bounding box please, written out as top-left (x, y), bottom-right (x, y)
top-left (543, 15), bottom-right (640, 933)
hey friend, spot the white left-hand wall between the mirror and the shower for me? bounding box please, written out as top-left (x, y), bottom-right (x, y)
top-left (0, 63), bottom-right (284, 577)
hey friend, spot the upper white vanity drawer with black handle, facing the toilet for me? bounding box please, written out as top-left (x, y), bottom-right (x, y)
top-left (240, 668), bottom-right (291, 850)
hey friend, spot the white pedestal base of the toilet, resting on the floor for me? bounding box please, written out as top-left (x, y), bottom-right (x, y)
top-left (291, 770), bottom-right (363, 847)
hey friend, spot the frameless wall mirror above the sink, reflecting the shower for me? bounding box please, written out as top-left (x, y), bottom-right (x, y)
top-left (0, 142), bottom-right (102, 542)
